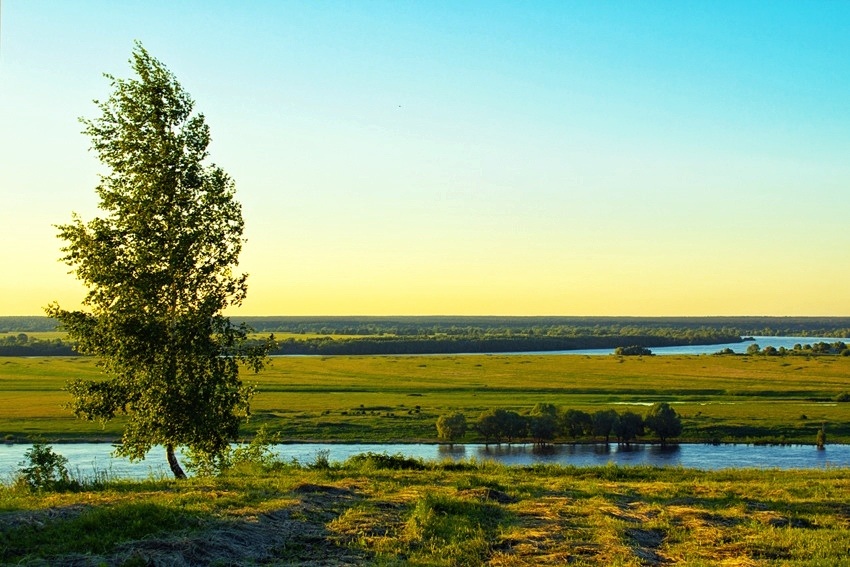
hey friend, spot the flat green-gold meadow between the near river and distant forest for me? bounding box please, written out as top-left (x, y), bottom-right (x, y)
top-left (0, 355), bottom-right (850, 443)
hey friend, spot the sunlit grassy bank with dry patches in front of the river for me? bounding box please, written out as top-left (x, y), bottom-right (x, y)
top-left (0, 456), bottom-right (850, 566)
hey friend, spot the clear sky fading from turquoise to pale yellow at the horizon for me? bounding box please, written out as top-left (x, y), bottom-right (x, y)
top-left (0, 0), bottom-right (850, 315)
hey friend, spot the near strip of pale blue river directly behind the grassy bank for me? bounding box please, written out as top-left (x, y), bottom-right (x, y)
top-left (0, 443), bottom-right (850, 481)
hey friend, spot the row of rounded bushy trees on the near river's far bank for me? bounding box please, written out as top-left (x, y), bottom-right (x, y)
top-left (436, 402), bottom-right (682, 445)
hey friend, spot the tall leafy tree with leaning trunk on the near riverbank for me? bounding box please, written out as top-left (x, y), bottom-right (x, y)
top-left (46, 43), bottom-right (271, 478)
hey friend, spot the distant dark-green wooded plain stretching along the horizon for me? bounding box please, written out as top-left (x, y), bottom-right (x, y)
top-left (0, 316), bottom-right (850, 356)
